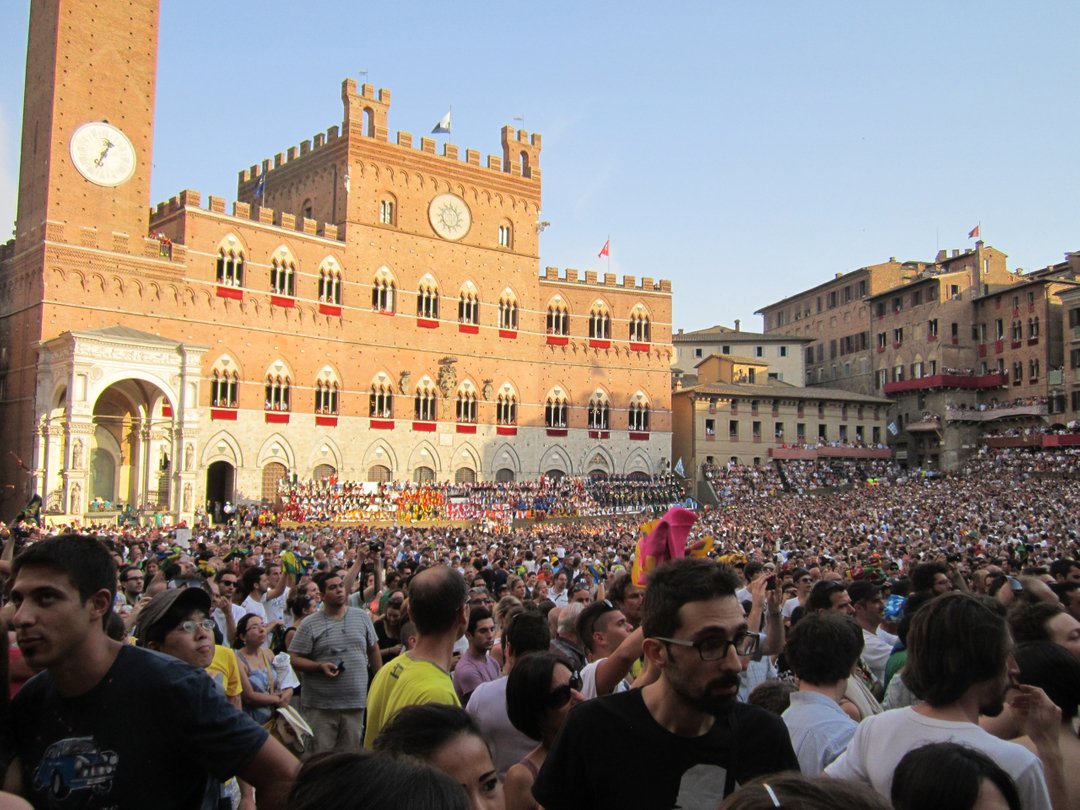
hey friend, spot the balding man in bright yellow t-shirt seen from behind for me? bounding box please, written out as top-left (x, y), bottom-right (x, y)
top-left (364, 566), bottom-right (469, 748)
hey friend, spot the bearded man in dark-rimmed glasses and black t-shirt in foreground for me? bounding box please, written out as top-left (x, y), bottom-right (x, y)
top-left (532, 557), bottom-right (799, 810)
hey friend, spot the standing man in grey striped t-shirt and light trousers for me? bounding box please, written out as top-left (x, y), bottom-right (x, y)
top-left (288, 571), bottom-right (382, 754)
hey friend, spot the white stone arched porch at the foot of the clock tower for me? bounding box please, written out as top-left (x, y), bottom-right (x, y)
top-left (32, 326), bottom-right (206, 522)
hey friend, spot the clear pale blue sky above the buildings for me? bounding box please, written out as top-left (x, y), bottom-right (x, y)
top-left (0, 0), bottom-right (1080, 329)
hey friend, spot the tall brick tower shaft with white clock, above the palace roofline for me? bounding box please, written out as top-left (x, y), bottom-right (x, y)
top-left (15, 0), bottom-right (159, 253)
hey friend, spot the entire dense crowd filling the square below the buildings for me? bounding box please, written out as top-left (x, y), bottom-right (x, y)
top-left (0, 449), bottom-right (1080, 810)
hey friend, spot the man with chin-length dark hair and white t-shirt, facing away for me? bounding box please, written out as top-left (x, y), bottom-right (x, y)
top-left (825, 592), bottom-right (1065, 808)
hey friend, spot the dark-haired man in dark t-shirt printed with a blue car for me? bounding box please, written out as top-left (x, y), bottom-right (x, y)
top-left (4, 535), bottom-right (298, 810)
